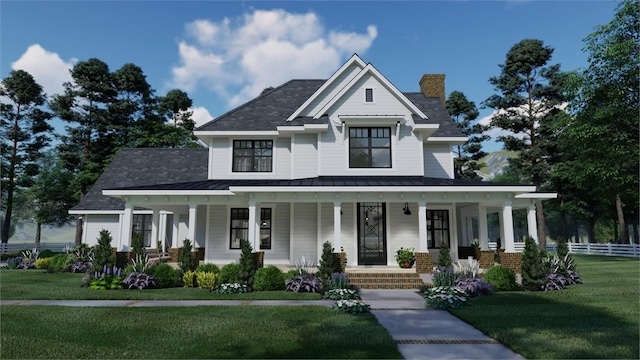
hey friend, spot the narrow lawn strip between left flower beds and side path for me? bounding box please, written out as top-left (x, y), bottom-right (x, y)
top-left (0, 269), bottom-right (321, 300)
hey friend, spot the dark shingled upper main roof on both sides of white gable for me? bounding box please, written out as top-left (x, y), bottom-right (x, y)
top-left (196, 80), bottom-right (463, 137)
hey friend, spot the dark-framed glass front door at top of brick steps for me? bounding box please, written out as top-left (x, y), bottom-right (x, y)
top-left (358, 203), bottom-right (387, 265)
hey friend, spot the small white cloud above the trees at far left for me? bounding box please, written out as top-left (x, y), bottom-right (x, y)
top-left (11, 44), bottom-right (77, 98)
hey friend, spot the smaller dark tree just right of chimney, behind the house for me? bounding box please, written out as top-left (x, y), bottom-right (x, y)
top-left (446, 91), bottom-right (489, 180)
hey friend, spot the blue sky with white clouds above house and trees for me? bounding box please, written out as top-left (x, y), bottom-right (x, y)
top-left (0, 0), bottom-right (617, 151)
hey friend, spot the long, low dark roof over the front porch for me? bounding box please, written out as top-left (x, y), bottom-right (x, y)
top-left (107, 176), bottom-right (529, 191)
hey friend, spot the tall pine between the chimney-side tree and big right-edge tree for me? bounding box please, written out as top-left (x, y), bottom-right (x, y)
top-left (484, 39), bottom-right (567, 249)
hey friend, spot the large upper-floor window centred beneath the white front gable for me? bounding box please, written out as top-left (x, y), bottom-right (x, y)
top-left (349, 128), bottom-right (391, 168)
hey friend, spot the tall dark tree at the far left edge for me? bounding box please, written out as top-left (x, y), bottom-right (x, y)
top-left (0, 70), bottom-right (53, 243)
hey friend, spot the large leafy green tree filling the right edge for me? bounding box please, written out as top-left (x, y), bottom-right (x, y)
top-left (562, 0), bottom-right (640, 243)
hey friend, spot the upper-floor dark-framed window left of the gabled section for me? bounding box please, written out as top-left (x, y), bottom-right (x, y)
top-left (232, 140), bottom-right (273, 172)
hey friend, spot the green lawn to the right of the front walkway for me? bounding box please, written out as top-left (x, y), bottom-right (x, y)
top-left (452, 255), bottom-right (640, 359)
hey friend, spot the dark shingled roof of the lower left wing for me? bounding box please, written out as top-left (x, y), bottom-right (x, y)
top-left (72, 149), bottom-right (209, 210)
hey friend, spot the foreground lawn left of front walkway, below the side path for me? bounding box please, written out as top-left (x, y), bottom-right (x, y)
top-left (0, 305), bottom-right (402, 359)
